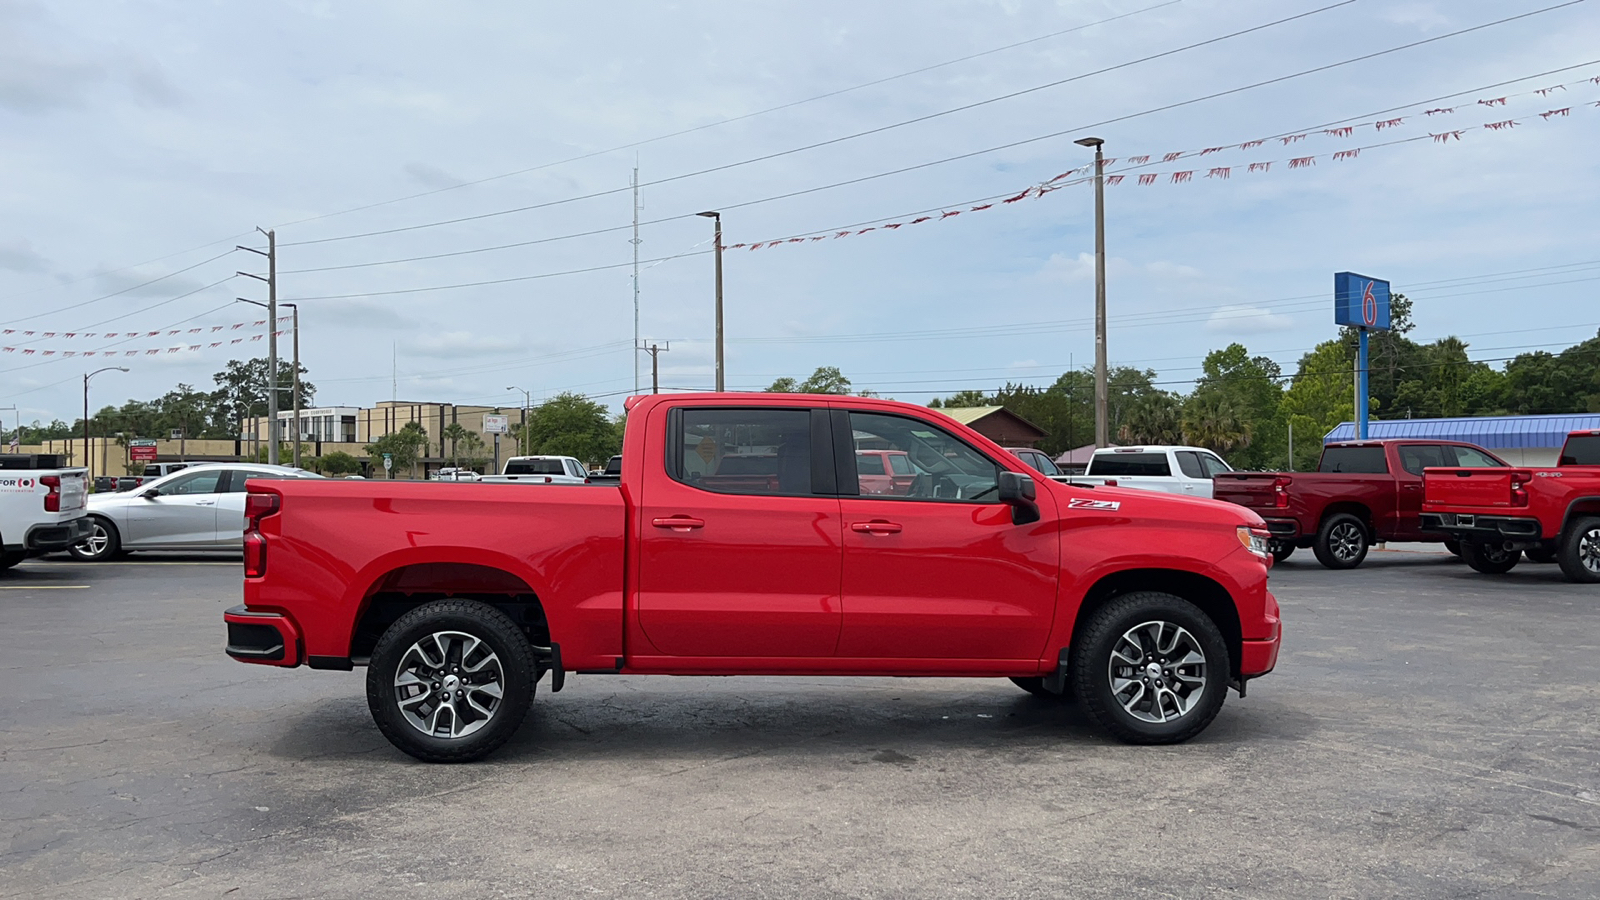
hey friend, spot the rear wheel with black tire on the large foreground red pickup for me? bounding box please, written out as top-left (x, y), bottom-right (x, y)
top-left (366, 599), bottom-right (538, 762)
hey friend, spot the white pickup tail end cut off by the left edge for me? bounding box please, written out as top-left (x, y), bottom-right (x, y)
top-left (0, 455), bottom-right (91, 570)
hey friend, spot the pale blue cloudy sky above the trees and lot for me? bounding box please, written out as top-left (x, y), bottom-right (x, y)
top-left (0, 0), bottom-right (1600, 423)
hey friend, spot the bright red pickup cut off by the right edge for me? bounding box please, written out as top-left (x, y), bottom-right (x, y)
top-left (1422, 431), bottom-right (1600, 583)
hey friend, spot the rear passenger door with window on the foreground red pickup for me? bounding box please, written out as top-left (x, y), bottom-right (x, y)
top-left (635, 405), bottom-right (854, 665)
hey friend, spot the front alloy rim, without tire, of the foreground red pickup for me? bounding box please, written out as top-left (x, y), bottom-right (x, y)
top-left (1110, 621), bottom-right (1206, 722)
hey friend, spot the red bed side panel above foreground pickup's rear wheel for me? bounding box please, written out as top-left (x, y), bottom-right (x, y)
top-left (245, 480), bottom-right (626, 669)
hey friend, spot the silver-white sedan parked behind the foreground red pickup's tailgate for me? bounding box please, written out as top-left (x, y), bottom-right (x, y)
top-left (70, 463), bottom-right (322, 560)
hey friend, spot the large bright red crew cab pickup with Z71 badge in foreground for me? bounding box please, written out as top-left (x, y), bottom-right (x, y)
top-left (224, 394), bottom-right (1280, 762)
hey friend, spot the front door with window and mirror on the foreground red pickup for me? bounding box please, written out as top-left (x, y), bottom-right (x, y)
top-left (834, 410), bottom-right (1061, 660)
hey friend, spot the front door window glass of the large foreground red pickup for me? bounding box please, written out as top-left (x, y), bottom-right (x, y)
top-left (850, 412), bottom-right (1000, 503)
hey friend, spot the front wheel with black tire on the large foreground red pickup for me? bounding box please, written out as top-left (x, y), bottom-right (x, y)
top-left (1072, 591), bottom-right (1230, 743)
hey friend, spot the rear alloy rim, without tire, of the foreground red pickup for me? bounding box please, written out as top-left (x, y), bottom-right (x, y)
top-left (394, 631), bottom-right (506, 738)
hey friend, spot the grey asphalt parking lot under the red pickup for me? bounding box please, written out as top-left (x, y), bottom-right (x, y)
top-left (0, 552), bottom-right (1600, 900)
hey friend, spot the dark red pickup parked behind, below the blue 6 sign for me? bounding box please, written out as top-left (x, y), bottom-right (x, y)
top-left (1211, 440), bottom-right (1506, 569)
